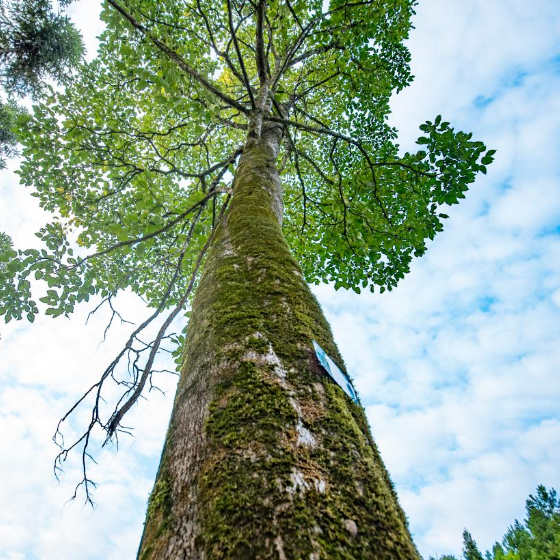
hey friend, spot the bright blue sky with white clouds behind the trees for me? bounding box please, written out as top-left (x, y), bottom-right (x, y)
top-left (0, 0), bottom-right (560, 560)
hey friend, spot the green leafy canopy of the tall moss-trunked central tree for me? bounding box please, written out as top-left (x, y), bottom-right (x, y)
top-left (0, 0), bottom-right (494, 490)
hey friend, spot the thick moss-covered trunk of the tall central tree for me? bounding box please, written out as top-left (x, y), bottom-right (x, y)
top-left (138, 124), bottom-right (419, 560)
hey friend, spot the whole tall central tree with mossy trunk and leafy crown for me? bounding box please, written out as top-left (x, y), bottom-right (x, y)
top-left (0, 0), bottom-right (492, 558)
